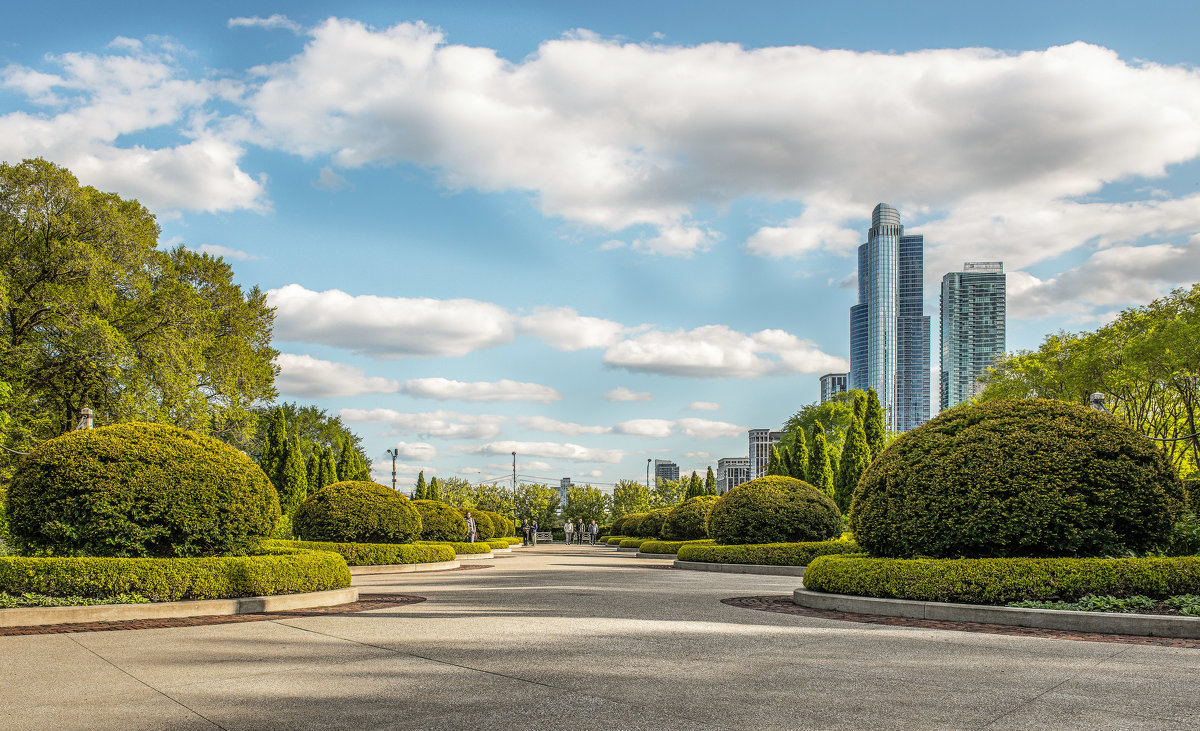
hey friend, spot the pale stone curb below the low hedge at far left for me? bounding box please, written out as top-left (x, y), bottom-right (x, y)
top-left (0, 587), bottom-right (359, 627)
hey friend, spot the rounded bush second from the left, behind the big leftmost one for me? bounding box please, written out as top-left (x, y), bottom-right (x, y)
top-left (292, 480), bottom-right (421, 544)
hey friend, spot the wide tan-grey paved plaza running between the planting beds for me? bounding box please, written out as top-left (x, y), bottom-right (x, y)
top-left (0, 544), bottom-right (1200, 731)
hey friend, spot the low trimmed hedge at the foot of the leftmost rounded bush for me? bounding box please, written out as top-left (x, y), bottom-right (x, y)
top-left (0, 549), bottom-right (350, 601)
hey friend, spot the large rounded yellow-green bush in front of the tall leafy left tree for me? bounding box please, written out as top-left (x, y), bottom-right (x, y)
top-left (7, 423), bottom-right (280, 558)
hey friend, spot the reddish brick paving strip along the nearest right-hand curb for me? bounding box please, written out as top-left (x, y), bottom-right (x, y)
top-left (721, 594), bottom-right (1200, 649)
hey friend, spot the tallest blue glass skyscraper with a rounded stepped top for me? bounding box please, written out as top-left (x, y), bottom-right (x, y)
top-left (850, 203), bottom-right (929, 431)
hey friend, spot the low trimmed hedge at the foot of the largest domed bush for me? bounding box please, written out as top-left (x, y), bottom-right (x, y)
top-left (804, 556), bottom-right (1200, 604)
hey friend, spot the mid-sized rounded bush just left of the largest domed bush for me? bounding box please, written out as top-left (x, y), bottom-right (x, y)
top-left (708, 475), bottom-right (842, 544)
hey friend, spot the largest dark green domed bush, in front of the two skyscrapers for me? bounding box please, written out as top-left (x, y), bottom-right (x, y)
top-left (851, 399), bottom-right (1183, 558)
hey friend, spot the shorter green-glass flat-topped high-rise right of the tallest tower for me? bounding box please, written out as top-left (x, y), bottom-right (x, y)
top-left (941, 262), bottom-right (1007, 409)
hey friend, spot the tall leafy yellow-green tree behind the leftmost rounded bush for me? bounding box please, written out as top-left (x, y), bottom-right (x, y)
top-left (0, 158), bottom-right (278, 459)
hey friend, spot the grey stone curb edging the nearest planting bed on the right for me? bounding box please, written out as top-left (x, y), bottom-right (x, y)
top-left (792, 588), bottom-right (1200, 639)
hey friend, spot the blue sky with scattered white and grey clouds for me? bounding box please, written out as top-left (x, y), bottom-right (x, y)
top-left (0, 2), bottom-right (1200, 485)
